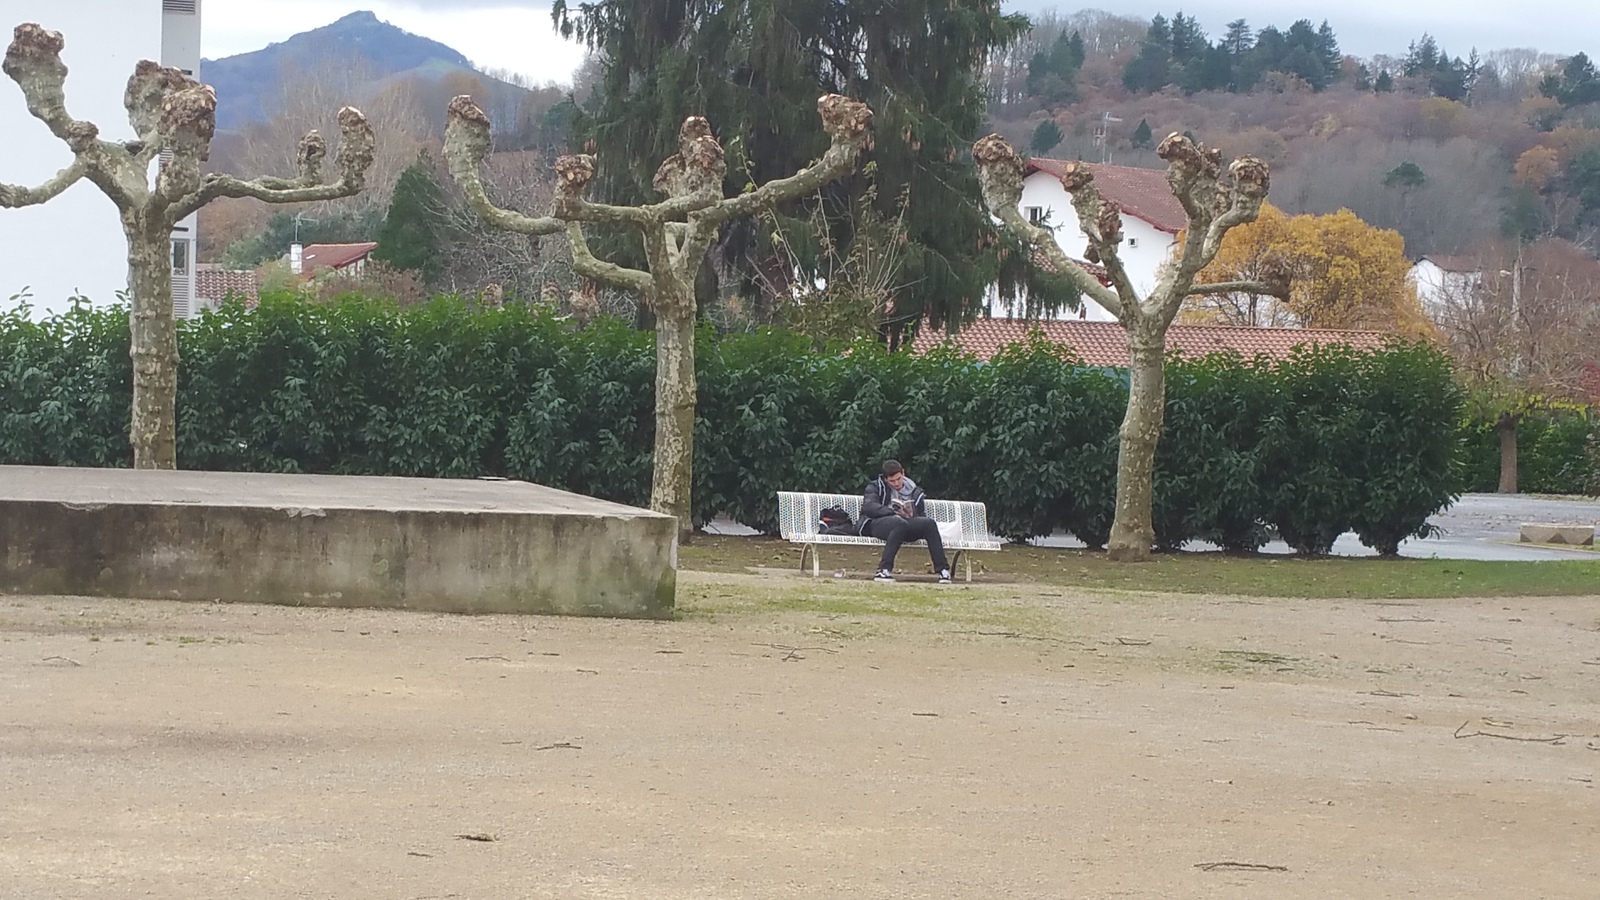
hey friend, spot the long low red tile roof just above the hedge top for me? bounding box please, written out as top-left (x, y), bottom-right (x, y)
top-left (912, 319), bottom-right (1387, 367)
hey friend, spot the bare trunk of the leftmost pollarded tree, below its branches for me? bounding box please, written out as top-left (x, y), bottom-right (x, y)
top-left (125, 224), bottom-right (178, 469)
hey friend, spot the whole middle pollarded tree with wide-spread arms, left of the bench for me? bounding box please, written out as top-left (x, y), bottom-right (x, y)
top-left (445, 94), bottom-right (872, 541)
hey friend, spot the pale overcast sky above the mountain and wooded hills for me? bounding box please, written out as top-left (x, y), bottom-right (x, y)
top-left (202, 0), bottom-right (1600, 82)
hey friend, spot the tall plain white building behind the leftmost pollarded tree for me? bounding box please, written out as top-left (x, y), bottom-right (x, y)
top-left (0, 0), bottom-right (200, 315)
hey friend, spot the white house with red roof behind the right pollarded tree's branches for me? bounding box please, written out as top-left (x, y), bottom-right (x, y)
top-left (989, 159), bottom-right (1187, 322)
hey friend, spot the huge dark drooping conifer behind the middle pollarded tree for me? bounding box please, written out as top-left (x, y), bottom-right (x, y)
top-left (554, 0), bottom-right (1075, 323)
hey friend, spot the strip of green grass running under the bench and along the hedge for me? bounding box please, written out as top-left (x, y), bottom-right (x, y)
top-left (678, 535), bottom-right (1600, 599)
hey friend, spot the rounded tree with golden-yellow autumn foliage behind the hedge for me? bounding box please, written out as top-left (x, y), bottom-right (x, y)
top-left (1182, 203), bottom-right (1432, 336)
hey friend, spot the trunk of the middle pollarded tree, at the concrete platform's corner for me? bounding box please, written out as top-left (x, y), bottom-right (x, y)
top-left (650, 282), bottom-right (696, 544)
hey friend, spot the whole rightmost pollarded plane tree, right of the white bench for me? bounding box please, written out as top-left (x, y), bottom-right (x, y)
top-left (973, 135), bottom-right (1288, 560)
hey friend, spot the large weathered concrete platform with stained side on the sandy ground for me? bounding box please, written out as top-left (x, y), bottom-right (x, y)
top-left (0, 466), bottom-right (677, 618)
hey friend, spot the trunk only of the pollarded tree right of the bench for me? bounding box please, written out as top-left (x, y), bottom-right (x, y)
top-left (1106, 322), bottom-right (1166, 562)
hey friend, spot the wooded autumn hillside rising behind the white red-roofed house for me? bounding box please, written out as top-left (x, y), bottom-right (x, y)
top-left (987, 11), bottom-right (1600, 258)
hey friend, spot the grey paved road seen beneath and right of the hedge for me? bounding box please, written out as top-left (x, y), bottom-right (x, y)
top-left (707, 493), bottom-right (1600, 559)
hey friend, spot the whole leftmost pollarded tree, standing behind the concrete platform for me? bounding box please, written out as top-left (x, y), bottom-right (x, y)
top-left (0, 24), bottom-right (373, 469)
